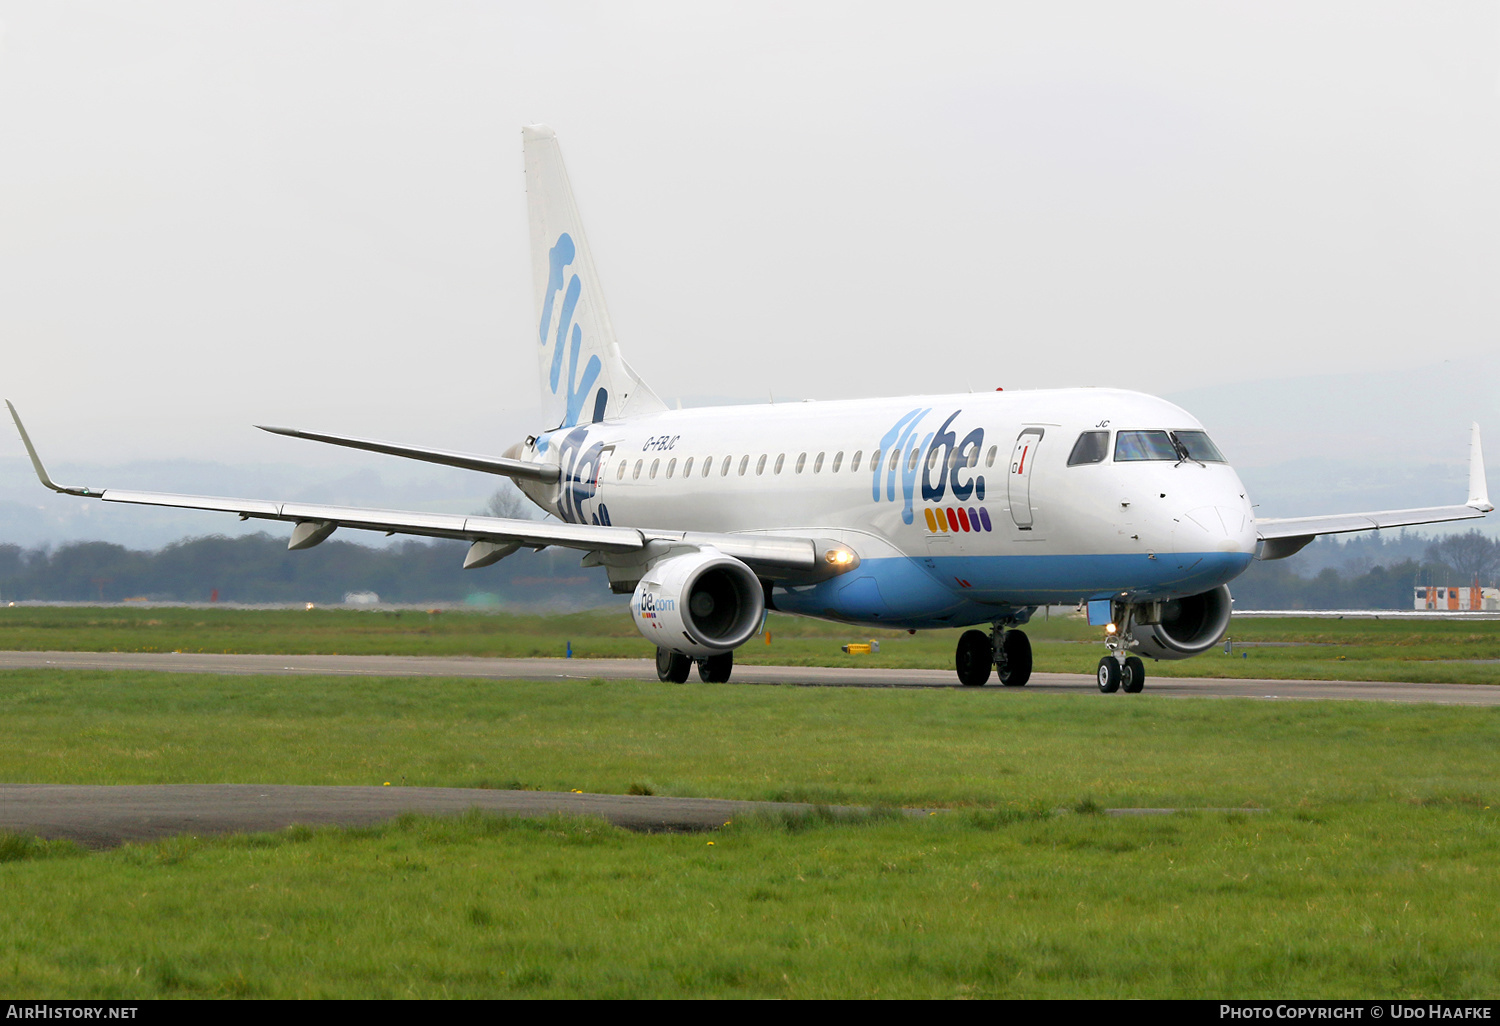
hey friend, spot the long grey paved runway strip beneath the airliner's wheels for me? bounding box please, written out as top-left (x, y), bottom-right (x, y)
top-left (0, 653), bottom-right (1500, 705)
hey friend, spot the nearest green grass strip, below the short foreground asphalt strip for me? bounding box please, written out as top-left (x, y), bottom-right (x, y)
top-left (0, 807), bottom-right (1500, 999)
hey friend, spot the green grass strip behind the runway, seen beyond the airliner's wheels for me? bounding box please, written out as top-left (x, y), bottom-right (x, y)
top-left (0, 606), bottom-right (1500, 684)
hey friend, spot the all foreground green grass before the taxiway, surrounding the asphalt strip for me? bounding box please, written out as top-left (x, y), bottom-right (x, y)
top-left (0, 671), bottom-right (1500, 998)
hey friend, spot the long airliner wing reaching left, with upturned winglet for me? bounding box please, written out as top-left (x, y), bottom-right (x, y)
top-left (6, 401), bottom-right (858, 578)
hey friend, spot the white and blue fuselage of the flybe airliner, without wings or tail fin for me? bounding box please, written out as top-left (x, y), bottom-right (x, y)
top-left (522, 389), bottom-right (1257, 629)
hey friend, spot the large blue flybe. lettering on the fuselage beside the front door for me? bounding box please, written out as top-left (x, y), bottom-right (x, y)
top-left (870, 407), bottom-right (984, 524)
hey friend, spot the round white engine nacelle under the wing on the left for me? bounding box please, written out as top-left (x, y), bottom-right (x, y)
top-left (630, 549), bottom-right (765, 659)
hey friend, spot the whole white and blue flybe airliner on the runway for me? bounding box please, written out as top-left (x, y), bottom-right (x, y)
top-left (8, 126), bottom-right (1494, 692)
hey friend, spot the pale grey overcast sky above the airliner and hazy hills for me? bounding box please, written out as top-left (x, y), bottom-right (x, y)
top-left (0, 0), bottom-right (1500, 474)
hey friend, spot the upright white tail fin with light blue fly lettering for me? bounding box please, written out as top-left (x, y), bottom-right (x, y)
top-left (521, 125), bottom-right (666, 428)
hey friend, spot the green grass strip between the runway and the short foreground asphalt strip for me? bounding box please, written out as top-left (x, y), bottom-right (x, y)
top-left (0, 671), bottom-right (1500, 807)
